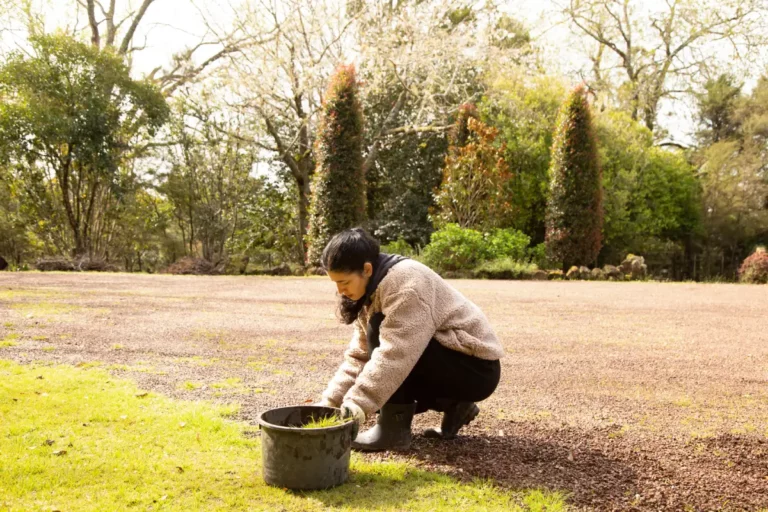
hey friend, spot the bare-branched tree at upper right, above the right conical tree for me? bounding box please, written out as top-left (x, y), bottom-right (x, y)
top-left (564, 0), bottom-right (766, 132)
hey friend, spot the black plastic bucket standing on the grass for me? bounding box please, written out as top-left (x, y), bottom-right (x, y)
top-left (258, 405), bottom-right (358, 489)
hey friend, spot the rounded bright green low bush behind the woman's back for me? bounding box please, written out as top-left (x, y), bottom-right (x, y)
top-left (422, 224), bottom-right (491, 272)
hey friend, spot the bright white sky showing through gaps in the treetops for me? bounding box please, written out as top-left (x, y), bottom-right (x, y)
top-left (0, 0), bottom-right (755, 143)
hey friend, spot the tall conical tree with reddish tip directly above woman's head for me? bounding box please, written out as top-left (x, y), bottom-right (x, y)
top-left (307, 66), bottom-right (365, 264)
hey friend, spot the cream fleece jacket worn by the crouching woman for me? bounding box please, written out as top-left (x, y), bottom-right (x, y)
top-left (323, 260), bottom-right (504, 416)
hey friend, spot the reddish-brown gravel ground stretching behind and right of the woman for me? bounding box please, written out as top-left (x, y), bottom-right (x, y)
top-left (0, 273), bottom-right (768, 510)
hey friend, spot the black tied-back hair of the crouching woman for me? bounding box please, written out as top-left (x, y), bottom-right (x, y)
top-left (320, 228), bottom-right (380, 324)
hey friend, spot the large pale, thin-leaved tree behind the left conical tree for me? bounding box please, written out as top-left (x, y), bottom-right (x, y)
top-left (222, 0), bottom-right (528, 258)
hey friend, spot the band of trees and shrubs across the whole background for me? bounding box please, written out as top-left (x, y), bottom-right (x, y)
top-left (0, 0), bottom-right (768, 279)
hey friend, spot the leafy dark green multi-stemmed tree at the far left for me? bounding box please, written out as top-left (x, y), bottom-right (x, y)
top-left (0, 35), bottom-right (168, 256)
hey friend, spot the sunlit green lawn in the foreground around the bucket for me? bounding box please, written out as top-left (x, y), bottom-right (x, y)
top-left (0, 361), bottom-right (566, 512)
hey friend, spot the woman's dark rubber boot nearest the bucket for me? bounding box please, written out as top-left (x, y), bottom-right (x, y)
top-left (352, 403), bottom-right (416, 452)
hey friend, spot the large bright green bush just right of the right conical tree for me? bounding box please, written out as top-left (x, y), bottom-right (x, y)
top-left (596, 111), bottom-right (701, 268)
